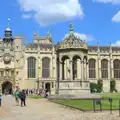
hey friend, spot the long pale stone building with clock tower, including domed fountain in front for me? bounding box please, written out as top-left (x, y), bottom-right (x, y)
top-left (0, 24), bottom-right (120, 95)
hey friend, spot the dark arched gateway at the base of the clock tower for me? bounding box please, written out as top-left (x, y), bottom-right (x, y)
top-left (2, 81), bottom-right (12, 94)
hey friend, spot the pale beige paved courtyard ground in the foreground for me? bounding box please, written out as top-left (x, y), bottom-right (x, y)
top-left (0, 96), bottom-right (120, 120)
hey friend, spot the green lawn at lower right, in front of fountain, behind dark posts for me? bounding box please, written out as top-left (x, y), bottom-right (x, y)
top-left (53, 93), bottom-right (120, 111)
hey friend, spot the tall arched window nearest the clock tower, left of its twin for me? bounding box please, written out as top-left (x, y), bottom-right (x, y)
top-left (28, 57), bottom-right (36, 78)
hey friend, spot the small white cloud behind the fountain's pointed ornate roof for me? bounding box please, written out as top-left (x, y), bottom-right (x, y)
top-left (65, 32), bottom-right (95, 42)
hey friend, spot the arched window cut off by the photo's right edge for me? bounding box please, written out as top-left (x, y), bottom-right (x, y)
top-left (113, 59), bottom-right (120, 78)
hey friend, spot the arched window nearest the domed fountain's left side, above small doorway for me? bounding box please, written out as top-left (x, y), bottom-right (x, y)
top-left (42, 57), bottom-right (50, 78)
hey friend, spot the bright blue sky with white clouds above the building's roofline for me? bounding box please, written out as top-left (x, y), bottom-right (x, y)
top-left (0, 0), bottom-right (120, 46)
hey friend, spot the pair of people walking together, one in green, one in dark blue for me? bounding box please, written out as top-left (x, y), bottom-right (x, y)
top-left (13, 89), bottom-right (26, 107)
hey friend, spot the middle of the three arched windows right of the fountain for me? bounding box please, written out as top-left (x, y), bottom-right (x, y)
top-left (101, 59), bottom-right (108, 78)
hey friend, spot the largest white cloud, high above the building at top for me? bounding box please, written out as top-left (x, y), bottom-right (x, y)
top-left (18, 0), bottom-right (84, 26)
